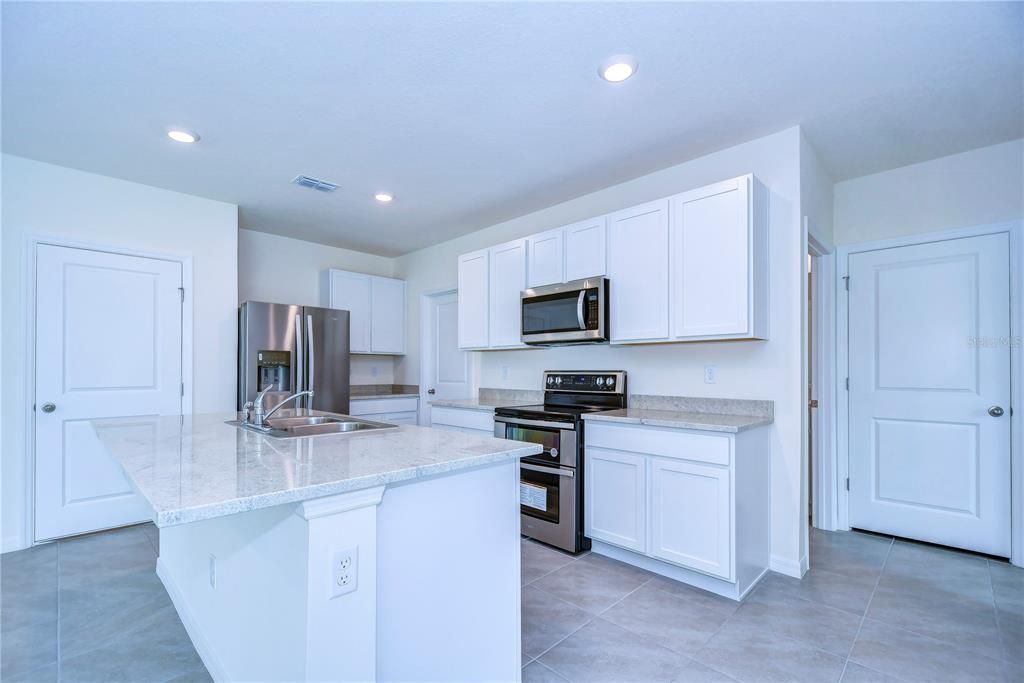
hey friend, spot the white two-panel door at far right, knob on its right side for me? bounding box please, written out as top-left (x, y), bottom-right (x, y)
top-left (849, 233), bottom-right (1010, 556)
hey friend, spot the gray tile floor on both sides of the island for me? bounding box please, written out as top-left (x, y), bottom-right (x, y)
top-left (0, 525), bottom-right (1024, 683)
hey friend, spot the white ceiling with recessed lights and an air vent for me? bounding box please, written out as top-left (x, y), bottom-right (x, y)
top-left (2, 2), bottom-right (1024, 255)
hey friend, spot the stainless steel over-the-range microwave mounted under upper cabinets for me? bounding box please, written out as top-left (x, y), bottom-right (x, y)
top-left (519, 278), bottom-right (608, 346)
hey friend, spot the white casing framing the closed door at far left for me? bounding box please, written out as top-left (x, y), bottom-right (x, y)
top-left (22, 234), bottom-right (194, 546)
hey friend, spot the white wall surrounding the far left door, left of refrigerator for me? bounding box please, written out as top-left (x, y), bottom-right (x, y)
top-left (0, 155), bottom-right (238, 551)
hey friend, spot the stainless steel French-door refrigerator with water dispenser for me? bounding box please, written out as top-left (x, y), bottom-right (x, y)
top-left (238, 301), bottom-right (349, 415)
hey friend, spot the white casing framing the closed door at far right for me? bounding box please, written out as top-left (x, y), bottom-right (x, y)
top-left (830, 221), bottom-right (1024, 566)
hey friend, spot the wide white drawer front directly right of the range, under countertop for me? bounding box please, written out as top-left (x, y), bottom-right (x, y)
top-left (587, 420), bottom-right (732, 465)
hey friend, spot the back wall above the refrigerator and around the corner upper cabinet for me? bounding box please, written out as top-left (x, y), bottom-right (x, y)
top-left (239, 230), bottom-right (394, 384)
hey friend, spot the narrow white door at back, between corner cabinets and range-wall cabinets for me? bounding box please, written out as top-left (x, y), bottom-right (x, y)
top-left (420, 292), bottom-right (473, 425)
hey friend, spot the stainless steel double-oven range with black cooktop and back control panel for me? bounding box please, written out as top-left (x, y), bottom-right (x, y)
top-left (495, 371), bottom-right (627, 553)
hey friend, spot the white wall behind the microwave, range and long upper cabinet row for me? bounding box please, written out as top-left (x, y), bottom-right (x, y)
top-left (395, 128), bottom-right (806, 572)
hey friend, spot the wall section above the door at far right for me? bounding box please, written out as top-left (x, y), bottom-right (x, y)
top-left (835, 140), bottom-right (1024, 245)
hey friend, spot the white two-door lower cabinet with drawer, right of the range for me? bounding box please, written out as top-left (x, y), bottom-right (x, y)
top-left (584, 420), bottom-right (771, 599)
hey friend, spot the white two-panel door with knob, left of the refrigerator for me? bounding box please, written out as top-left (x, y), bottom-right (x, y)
top-left (35, 245), bottom-right (182, 541)
